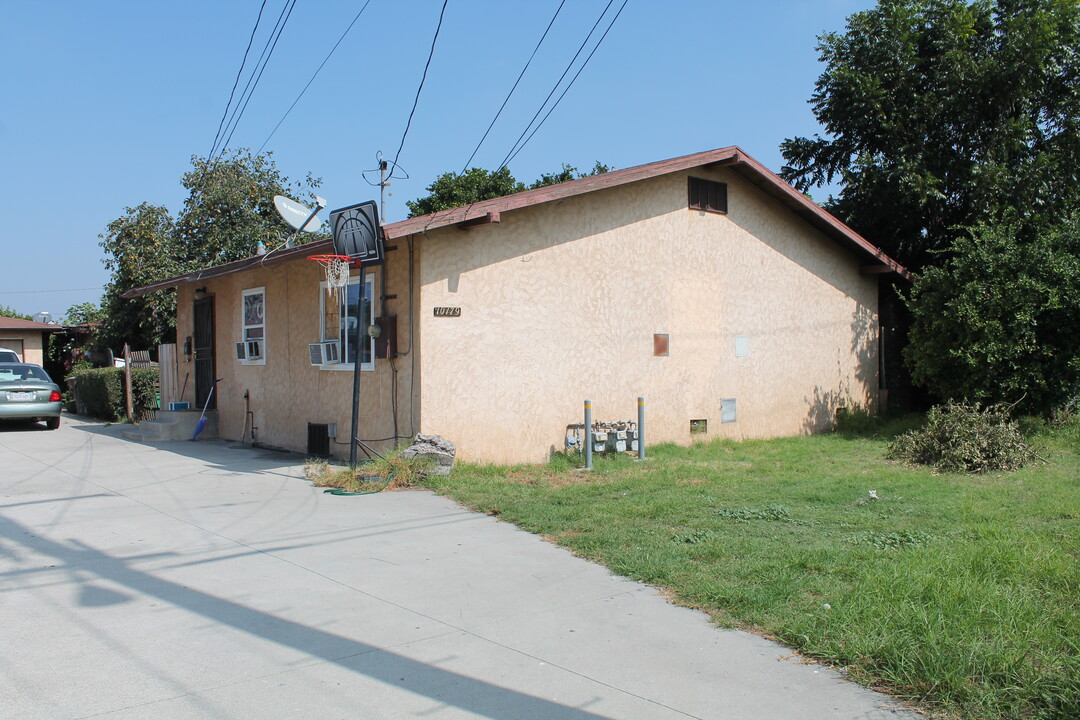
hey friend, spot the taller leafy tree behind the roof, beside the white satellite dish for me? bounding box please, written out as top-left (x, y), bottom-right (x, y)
top-left (175, 149), bottom-right (322, 268)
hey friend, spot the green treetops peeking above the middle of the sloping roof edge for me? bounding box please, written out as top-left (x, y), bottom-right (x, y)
top-left (405, 161), bottom-right (611, 217)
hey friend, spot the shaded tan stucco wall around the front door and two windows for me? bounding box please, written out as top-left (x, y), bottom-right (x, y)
top-left (176, 246), bottom-right (413, 459)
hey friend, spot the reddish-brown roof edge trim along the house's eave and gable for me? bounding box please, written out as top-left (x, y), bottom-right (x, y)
top-left (123, 145), bottom-right (912, 298)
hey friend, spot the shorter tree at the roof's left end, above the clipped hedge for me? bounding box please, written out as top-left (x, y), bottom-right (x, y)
top-left (99, 203), bottom-right (181, 349)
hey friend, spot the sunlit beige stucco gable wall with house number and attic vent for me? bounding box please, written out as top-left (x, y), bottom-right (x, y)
top-left (418, 169), bottom-right (878, 462)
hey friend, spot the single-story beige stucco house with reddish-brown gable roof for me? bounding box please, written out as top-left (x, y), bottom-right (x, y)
top-left (124, 147), bottom-right (907, 462)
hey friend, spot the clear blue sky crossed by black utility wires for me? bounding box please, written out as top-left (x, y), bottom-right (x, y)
top-left (0, 0), bottom-right (875, 317)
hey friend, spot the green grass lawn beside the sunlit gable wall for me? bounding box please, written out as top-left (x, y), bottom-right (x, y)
top-left (427, 421), bottom-right (1080, 719)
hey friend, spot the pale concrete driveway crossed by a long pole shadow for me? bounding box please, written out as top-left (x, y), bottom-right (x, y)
top-left (0, 417), bottom-right (918, 720)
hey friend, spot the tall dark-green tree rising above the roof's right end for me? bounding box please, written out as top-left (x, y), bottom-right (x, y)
top-left (781, 0), bottom-right (1080, 269)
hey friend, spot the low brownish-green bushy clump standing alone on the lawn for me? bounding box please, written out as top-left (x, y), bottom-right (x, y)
top-left (886, 402), bottom-right (1035, 473)
